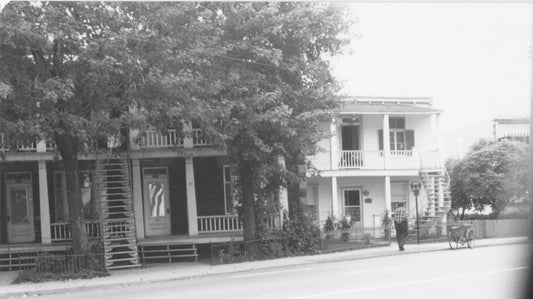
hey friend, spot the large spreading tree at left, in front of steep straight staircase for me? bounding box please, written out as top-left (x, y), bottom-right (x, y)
top-left (0, 2), bottom-right (227, 253)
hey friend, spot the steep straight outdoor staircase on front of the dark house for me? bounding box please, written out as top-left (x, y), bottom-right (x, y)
top-left (96, 156), bottom-right (140, 270)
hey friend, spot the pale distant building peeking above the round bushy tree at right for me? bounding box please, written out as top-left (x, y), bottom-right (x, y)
top-left (492, 118), bottom-right (529, 143)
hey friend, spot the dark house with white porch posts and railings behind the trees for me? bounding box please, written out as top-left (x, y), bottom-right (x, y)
top-left (0, 129), bottom-right (288, 269)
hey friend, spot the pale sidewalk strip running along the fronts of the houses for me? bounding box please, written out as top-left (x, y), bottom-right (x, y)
top-left (0, 237), bottom-right (528, 298)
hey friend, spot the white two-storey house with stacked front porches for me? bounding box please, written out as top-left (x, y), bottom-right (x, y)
top-left (306, 97), bottom-right (451, 234)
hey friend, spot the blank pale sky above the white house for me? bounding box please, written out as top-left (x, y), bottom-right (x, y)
top-left (332, 3), bottom-right (532, 157)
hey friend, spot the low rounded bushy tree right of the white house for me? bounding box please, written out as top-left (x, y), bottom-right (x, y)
top-left (450, 140), bottom-right (529, 219)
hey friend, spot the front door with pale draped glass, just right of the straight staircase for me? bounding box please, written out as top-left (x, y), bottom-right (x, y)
top-left (143, 167), bottom-right (170, 236)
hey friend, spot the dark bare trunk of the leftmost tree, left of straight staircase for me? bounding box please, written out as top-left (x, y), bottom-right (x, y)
top-left (55, 135), bottom-right (89, 254)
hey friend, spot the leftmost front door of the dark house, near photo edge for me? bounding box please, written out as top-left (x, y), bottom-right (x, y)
top-left (6, 172), bottom-right (35, 243)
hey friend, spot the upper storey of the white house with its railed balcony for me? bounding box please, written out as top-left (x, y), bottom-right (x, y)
top-left (308, 98), bottom-right (442, 175)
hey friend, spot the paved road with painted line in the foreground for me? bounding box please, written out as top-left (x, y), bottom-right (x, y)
top-left (28, 244), bottom-right (529, 299)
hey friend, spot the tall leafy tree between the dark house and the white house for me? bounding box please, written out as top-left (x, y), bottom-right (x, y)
top-left (209, 2), bottom-right (349, 246)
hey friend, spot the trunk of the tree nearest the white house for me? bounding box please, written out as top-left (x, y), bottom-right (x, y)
top-left (239, 161), bottom-right (256, 254)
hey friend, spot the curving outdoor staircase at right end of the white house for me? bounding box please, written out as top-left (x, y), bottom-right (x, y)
top-left (419, 168), bottom-right (451, 235)
